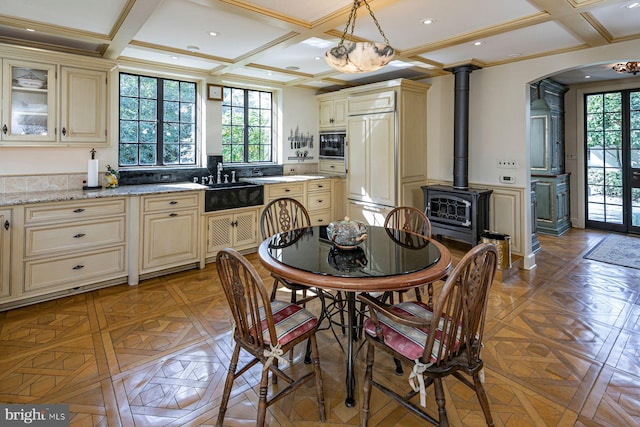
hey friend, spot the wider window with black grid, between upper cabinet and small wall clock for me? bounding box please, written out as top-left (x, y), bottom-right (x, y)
top-left (119, 73), bottom-right (197, 167)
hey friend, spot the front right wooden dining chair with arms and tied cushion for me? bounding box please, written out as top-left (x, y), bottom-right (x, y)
top-left (358, 243), bottom-right (498, 426)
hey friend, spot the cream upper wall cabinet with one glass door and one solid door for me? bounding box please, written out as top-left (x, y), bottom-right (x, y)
top-left (0, 54), bottom-right (108, 146)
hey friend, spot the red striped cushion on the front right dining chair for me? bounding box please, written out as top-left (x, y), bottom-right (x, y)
top-left (364, 301), bottom-right (461, 363)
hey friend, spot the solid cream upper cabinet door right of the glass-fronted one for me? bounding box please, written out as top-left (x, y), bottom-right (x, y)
top-left (60, 67), bottom-right (107, 143)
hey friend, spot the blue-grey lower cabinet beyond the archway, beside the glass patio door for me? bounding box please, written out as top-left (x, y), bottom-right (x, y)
top-left (532, 173), bottom-right (571, 236)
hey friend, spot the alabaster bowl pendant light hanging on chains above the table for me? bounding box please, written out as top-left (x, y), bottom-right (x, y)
top-left (325, 0), bottom-right (394, 74)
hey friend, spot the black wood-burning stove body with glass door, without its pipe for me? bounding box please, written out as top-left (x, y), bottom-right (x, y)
top-left (422, 185), bottom-right (492, 246)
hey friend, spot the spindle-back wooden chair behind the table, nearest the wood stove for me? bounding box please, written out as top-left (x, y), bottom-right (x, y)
top-left (384, 206), bottom-right (433, 306)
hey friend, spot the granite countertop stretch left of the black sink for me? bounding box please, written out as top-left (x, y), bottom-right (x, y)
top-left (0, 182), bottom-right (207, 207)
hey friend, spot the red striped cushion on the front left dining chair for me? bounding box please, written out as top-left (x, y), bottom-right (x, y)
top-left (251, 300), bottom-right (318, 345)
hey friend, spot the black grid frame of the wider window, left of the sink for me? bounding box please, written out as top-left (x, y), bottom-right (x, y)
top-left (118, 71), bottom-right (200, 169)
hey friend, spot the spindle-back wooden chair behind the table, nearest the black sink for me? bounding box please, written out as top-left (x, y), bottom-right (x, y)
top-left (260, 197), bottom-right (318, 305)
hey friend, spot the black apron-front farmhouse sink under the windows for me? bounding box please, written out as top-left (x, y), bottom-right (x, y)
top-left (204, 182), bottom-right (264, 212)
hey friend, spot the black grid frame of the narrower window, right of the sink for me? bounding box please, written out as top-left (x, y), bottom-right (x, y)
top-left (221, 86), bottom-right (275, 165)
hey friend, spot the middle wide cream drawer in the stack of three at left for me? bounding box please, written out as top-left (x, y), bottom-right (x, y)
top-left (25, 217), bottom-right (125, 257)
